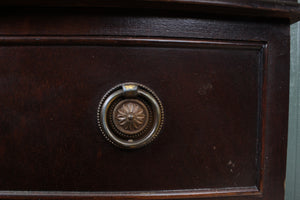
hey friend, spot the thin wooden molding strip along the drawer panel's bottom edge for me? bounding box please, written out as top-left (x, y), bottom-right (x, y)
top-left (0, 186), bottom-right (262, 200)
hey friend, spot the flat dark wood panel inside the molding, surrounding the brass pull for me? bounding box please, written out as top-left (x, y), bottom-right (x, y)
top-left (0, 37), bottom-right (263, 198)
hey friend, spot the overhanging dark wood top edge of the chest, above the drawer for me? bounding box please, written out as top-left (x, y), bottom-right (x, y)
top-left (0, 0), bottom-right (300, 23)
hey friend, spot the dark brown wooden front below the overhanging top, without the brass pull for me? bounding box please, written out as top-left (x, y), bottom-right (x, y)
top-left (0, 3), bottom-right (289, 200)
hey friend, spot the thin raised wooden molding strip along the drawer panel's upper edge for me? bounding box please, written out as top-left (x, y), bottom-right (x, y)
top-left (0, 36), bottom-right (266, 50)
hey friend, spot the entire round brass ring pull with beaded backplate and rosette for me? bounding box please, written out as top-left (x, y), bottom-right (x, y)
top-left (97, 82), bottom-right (163, 149)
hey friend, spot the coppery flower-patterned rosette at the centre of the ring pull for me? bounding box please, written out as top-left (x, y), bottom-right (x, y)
top-left (114, 99), bottom-right (148, 134)
